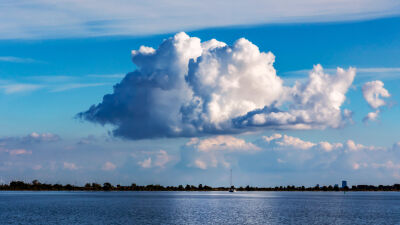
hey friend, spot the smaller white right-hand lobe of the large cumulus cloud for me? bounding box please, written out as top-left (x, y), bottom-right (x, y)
top-left (236, 65), bottom-right (356, 129)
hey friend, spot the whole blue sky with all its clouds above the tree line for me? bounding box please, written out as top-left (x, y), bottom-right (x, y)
top-left (0, 0), bottom-right (400, 186)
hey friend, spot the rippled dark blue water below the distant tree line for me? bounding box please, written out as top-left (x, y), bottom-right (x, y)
top-left (0, 191), bottom-right (400, 225)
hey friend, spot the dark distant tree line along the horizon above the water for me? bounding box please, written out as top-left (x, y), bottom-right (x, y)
top-left (0, 180), bottom-right (400, 191)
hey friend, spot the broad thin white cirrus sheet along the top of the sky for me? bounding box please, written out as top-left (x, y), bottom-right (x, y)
top-left (0, 0), bottom-right (400, 39)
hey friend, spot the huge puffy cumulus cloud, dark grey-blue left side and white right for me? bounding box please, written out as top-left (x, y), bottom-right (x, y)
top-left (78, 33), bottom-right (355, 139)
